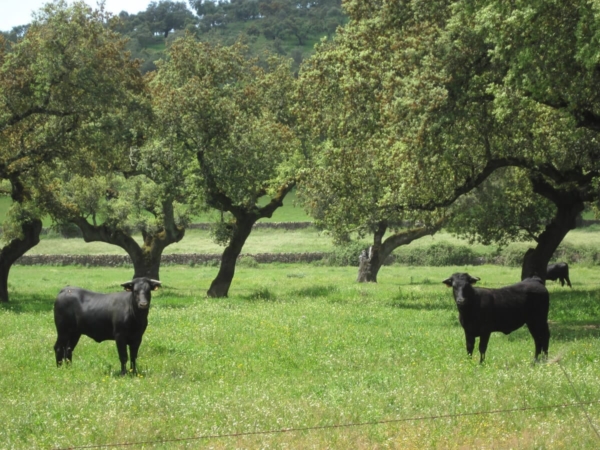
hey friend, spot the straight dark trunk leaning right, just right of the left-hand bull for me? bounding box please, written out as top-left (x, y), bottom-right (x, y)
top-left (206, 214), bottom-right (257, 298)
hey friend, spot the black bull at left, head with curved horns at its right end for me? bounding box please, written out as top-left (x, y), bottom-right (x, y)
top-left (54, 278), bottom-right (161, 375)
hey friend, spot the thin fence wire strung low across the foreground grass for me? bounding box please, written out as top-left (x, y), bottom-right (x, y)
top-left (53, 362), bottom-right (600, 450)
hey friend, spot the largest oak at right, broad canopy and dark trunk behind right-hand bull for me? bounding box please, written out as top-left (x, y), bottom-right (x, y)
top-left (300, 0), bottom-right (599, 276)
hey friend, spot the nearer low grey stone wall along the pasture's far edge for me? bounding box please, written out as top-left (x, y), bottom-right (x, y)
top-left (15, 252), bottom-right (327, 267)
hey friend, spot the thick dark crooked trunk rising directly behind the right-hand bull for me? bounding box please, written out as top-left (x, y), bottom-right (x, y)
top-left (521, 183), bottom-right (585, 281)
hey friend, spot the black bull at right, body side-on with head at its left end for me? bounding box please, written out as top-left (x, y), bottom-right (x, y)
top-left (443, 273), bottom-right (550, 363)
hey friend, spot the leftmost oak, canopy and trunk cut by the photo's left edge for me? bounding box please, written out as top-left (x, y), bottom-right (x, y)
top-left (0, 1), bottom-right (144, 301)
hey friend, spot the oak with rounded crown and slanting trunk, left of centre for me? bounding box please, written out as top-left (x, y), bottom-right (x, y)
top-left (150, 35), bottom-right (303, 297)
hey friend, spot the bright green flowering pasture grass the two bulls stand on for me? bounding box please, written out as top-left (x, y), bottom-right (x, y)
top-left (0, 264), bottom-right (600, 449)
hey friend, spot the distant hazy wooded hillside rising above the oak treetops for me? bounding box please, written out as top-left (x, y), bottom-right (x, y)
top-left (3, 0), bottom-right (347, 72)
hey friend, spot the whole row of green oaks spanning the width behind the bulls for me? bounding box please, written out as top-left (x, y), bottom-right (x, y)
top-left (0, 0), bottom-right (600, 300)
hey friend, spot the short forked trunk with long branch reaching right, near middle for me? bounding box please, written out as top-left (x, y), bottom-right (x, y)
top-left (358, 217), bottom-right (446, 283)
